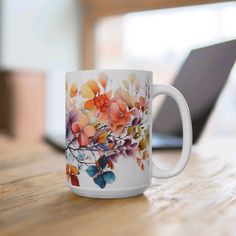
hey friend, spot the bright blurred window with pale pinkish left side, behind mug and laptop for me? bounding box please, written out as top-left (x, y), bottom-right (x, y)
top-left (95, 2), bottom-right (236, 83)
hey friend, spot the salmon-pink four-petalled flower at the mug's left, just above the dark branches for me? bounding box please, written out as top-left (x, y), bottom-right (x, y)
top-left (71, 113), bottom-right (95, 147)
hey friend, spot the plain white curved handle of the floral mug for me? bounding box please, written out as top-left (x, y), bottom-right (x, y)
top-left (152, 85), bottom-right (192, 178)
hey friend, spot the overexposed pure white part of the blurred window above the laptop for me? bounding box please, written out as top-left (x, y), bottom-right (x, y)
top-left (123, 3), bottom-right (236, 62)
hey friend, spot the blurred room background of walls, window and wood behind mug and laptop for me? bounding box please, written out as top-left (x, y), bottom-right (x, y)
top-left (0, 0), bottom-right (236, 142)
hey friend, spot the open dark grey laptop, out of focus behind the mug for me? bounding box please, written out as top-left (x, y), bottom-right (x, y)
top-left (45, 40), bottom-right (236, 151)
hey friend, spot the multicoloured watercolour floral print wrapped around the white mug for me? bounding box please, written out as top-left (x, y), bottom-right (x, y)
top-left (66, 72), bottom-right (150, 189)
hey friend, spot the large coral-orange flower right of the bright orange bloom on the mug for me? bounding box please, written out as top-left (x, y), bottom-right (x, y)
top-left (110, 99), bottom-right (131, 133)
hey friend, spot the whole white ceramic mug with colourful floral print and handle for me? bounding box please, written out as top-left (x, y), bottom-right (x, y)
top-left (66, 70), bottom-right (192, 198)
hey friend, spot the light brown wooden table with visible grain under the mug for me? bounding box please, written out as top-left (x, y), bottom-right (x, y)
top-left (0, 138), bottom-right (236, 236)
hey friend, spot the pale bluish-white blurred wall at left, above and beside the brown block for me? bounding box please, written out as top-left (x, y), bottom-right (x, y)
top-left (1, 0), bottom-right (82, 134)
